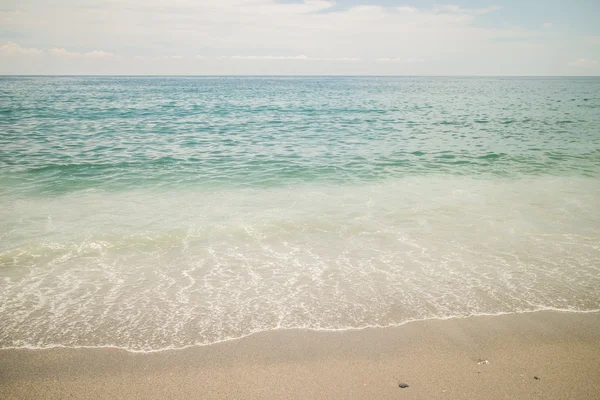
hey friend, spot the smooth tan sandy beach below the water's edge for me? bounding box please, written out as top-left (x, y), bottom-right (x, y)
top-left (0, 312), bottom-right (600, 400)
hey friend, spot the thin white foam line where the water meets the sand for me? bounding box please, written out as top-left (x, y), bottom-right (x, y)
top-left (0, 307), bottom-right (600, 354)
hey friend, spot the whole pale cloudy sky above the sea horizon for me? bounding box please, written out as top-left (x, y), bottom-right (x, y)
top-left (0, 0), bottom-right (600, 76)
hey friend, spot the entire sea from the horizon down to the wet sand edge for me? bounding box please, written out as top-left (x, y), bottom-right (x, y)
top-left (0, 77), bottom-right (600, 350)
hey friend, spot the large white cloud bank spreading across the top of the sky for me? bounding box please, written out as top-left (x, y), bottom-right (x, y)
top-left (0, 0), bottom-right (524, 58)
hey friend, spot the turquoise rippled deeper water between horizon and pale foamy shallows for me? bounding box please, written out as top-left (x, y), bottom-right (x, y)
top-left (0, 77), bottom-right (600, 194)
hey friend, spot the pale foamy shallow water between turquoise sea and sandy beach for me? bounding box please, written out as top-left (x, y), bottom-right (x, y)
top-left (0, 176), bottom-right (600, 350)
